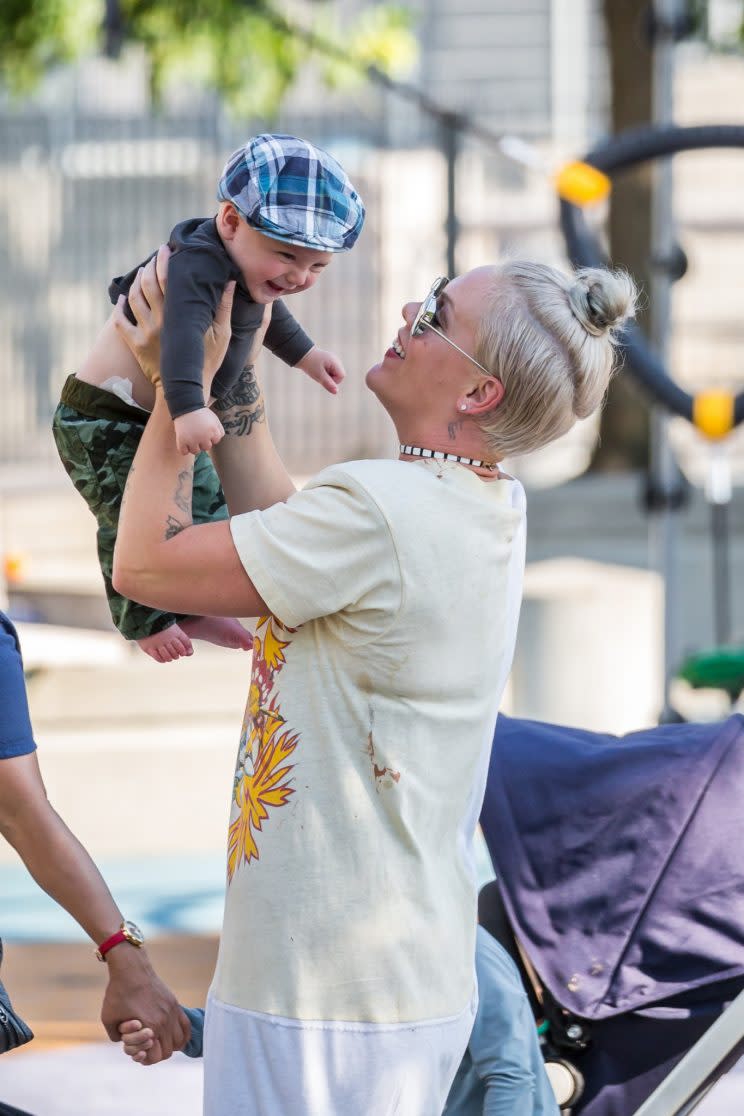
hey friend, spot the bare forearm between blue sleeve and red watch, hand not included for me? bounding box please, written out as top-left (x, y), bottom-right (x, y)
top-left (0, 753), bottom-right (122, 943)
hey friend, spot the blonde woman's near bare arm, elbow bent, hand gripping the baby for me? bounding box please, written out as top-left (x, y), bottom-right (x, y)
top-left (113, 264), bottom-right (269, 616)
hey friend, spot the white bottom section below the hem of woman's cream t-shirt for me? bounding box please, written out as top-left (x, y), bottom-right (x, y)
top-left (204, 994), bottom-right (476, 1116)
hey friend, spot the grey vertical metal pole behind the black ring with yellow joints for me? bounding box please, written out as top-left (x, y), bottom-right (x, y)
top-left (649, 0), bottom-right (680, 721)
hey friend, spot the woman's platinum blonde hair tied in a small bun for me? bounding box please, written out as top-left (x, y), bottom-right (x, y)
top-left (475, 260), bottom-right (636, 458)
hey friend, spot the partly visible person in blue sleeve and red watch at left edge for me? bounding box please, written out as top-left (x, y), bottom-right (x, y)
top-left (0, 612), bottom-right (190, 1071)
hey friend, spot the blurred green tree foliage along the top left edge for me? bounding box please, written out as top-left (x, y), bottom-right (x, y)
top-left (0, 0), bottom-right (415, 115)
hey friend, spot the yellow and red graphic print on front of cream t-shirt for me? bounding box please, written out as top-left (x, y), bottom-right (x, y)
top-left (228, 616), bottom-right (300, 884)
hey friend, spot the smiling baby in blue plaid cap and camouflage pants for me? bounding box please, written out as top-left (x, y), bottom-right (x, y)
top-left (52, 135), bottom-right (365, 663)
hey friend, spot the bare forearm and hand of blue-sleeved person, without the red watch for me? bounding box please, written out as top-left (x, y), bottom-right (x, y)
top-left (0, 752), bottom-right (189, 1058)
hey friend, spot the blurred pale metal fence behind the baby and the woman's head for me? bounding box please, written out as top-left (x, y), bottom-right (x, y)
top-left (0, 96), bottom-right (575, 475)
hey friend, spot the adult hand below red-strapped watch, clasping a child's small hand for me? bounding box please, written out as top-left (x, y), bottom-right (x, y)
top-left (100, 943), bottom-right (191, 1065)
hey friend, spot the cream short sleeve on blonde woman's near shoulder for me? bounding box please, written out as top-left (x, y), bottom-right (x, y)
top-left (230, 469), bottom-right (402, 633)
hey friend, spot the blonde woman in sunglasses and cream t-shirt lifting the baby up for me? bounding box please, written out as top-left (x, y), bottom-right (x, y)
top-left (114, 253), bottom-right (632, 1116)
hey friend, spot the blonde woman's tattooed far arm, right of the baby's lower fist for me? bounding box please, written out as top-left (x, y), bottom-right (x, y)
top-left (212, 368), bottom-right (294, 516)
